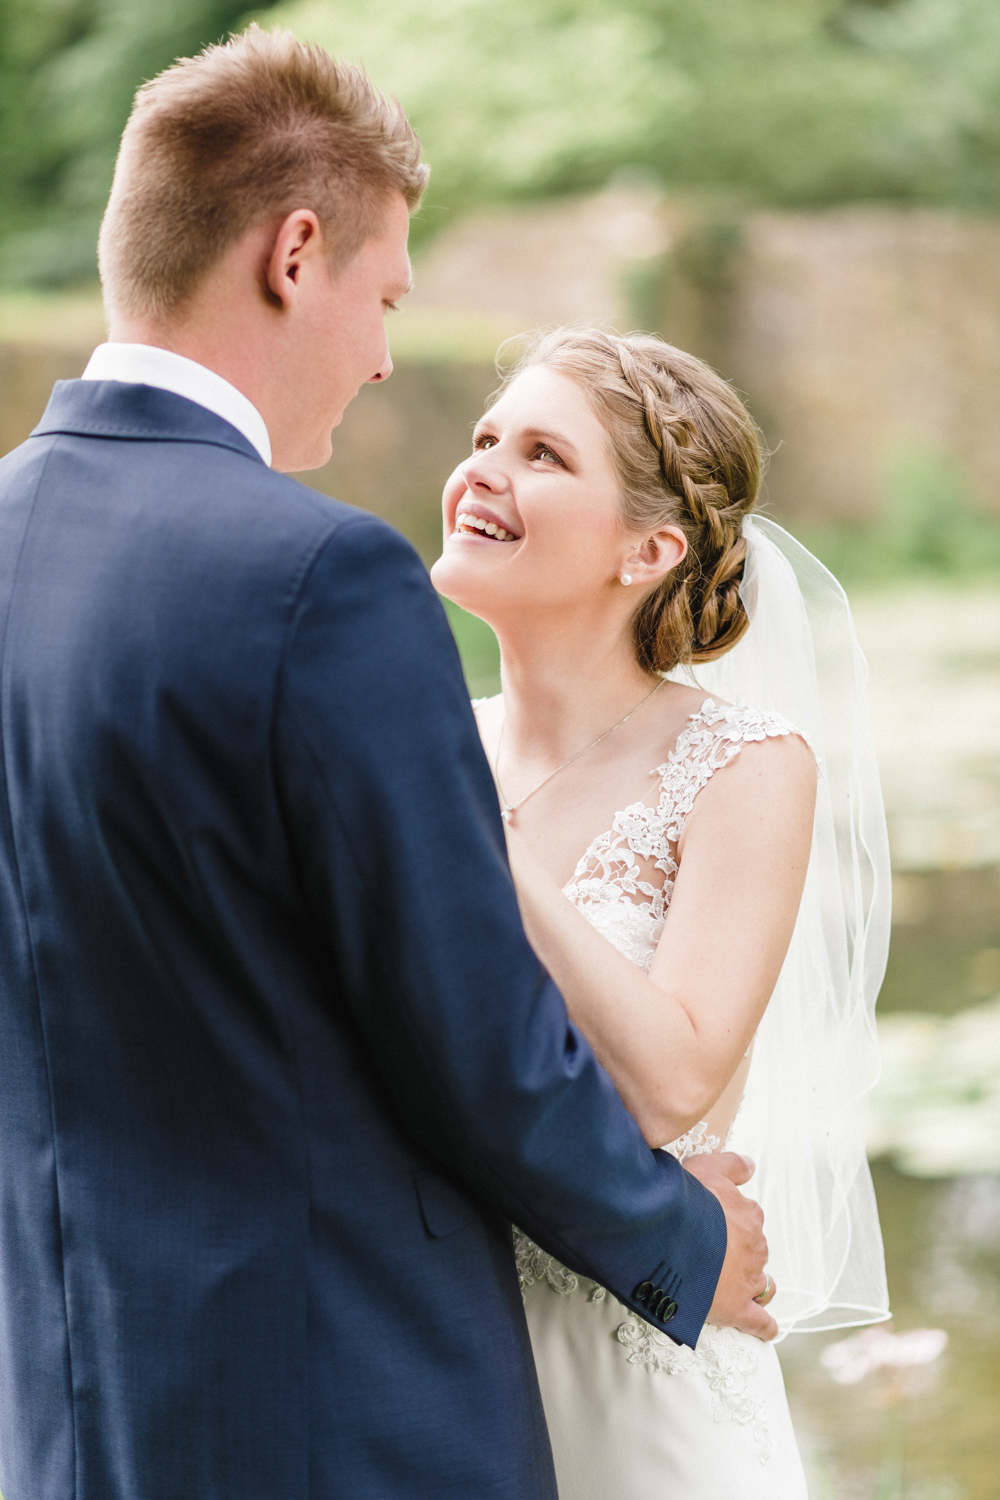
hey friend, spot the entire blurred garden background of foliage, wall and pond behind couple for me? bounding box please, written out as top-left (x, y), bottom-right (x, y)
top-left (0, 0), bottom-right (1000, 1500)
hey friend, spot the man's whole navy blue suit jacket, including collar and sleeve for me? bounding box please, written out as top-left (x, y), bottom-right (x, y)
top-left (0, 381), bottom-right (726, 1500)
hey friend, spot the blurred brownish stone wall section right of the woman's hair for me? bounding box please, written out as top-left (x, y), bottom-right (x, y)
top-left (661, 210), bottom-right (1000, 519)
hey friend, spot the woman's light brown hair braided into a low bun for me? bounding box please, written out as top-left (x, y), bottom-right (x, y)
top-left (501, 329), bottom-right (763, 672)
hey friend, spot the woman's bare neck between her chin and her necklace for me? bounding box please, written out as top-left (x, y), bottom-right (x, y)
top-left (496, 621), bottom-right (657, 762)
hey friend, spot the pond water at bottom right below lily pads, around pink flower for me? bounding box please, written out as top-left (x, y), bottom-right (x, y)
top-left (780, 1163), bottom-right (1000, 1500)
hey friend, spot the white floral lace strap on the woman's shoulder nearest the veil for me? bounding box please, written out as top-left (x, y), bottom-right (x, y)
top-left (652, 698), bottom-right (811, 843)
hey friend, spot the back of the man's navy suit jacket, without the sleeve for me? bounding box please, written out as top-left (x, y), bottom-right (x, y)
top-left (0, 387), bottom-right (547, 1500)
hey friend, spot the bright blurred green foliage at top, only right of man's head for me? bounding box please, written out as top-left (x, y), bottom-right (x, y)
top-left (262, 0), bottom-right (1000, 219)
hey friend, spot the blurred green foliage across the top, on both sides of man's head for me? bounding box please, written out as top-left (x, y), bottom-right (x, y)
top-left (0, 0), bottom-right (1000, 282)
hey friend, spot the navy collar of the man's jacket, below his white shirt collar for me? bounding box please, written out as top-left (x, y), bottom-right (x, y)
top-left (31, 380), bottom-right (264, 465)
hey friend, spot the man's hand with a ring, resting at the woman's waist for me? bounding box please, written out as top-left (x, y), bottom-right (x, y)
top-left (684, 1151), bottom-right (778, 1343)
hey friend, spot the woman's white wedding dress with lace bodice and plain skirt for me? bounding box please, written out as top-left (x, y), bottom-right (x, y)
top-left (516, 699), bottom-right (807, 1500)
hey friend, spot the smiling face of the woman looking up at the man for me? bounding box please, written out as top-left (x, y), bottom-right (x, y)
top-left (430, 366), bottom-right (636, 624)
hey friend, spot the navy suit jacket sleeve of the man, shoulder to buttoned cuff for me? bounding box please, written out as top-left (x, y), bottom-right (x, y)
top-left (274, 516), bottom-right (726, 1346)
